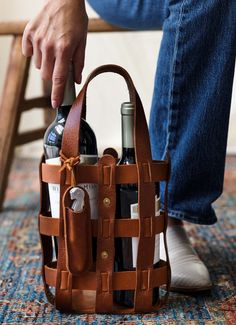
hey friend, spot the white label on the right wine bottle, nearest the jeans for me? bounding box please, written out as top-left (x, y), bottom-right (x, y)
top-left (130, 196), bottom-right (160, 267)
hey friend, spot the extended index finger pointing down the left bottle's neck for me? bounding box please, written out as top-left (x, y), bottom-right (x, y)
top-left (51, 56), bottom-right (70, 108)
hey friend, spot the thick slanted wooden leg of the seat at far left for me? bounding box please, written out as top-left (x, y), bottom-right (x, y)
top-left (0, 36), bottom-right (30, 209)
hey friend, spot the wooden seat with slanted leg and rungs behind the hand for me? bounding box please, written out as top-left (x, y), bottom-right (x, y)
top-left (0, 18), bottom-right (159, 209)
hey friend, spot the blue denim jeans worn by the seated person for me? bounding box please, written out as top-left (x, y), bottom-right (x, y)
top-left (89, 0), bottom-right (236, 224)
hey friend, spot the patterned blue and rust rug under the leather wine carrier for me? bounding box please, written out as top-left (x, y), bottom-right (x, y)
top-left (0, 157), bottom-right (236, 325)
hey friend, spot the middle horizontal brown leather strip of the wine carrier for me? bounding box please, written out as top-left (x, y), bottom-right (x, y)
top-left (39, 212), bottom-right (165, 237)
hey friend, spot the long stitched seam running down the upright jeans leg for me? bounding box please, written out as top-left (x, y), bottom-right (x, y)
top-left (162, 0), bottom-right (187, 159)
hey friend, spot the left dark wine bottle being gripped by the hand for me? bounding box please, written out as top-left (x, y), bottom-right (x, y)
top-left (44, 64), bottom-right (98, 256)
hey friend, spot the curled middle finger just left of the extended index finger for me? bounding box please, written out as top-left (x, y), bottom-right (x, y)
top-left (41, 44), bottom-right (55, 80)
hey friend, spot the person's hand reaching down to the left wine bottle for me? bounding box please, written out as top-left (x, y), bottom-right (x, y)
top-left (22, 0), bottom-right (88, 108)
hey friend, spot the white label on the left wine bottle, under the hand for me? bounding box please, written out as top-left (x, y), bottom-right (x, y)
top-left (46, 155), bottom-right (98, 219)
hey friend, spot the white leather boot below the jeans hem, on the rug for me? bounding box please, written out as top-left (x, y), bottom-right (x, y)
top-left (160, 225), bottom-right (212, 292)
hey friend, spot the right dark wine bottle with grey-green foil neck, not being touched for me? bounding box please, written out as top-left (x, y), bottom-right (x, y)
top-left (114, 102), bottom-right (159, 307)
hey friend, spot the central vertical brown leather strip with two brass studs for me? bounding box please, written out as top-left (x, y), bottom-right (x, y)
top-left (95, 155), bottom-right (116, 313)
